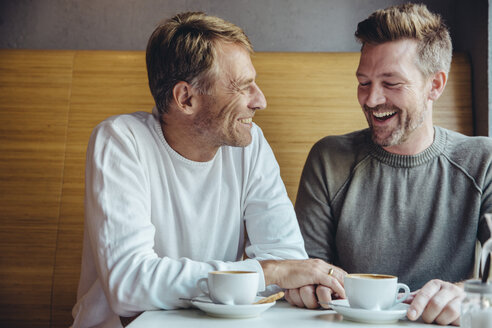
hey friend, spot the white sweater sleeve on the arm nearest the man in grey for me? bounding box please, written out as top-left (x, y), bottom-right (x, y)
top-left (243, 126), bottom-right (307, 261)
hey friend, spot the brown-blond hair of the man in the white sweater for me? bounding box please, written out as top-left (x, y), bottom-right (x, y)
top-left (146, 12), bottom-right (253, 116)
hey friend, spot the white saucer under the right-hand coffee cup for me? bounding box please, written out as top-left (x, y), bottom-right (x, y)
top-left (330, 300), bottom-right (409, 323)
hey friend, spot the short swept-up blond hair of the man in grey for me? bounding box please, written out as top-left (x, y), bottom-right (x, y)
top-left (355, 3), bottom-right (453, 77)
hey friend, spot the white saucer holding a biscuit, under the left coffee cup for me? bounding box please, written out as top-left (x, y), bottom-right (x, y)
top-left (191, 296), bottom-right (275, 319)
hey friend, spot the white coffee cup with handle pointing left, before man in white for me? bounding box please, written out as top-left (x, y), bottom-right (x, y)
top-left (197, 271), bottom-right (259, 305)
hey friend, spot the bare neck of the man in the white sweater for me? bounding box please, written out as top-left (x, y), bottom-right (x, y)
top-left (161, 120), bottom-right (219, 162)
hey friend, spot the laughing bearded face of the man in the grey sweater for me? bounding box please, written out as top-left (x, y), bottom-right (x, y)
top-left (356, 39), bottom-right (433, 153)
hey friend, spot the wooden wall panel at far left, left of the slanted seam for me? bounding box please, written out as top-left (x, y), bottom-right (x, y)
top-left (0, 50), bottom-right (74, 327)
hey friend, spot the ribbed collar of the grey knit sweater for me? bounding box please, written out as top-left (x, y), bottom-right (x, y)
top-left (367, 126), bottom-right (446, 167)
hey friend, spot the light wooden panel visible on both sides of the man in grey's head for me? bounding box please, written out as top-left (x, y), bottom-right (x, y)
top-left (253, 52), bottom-right (473, 202)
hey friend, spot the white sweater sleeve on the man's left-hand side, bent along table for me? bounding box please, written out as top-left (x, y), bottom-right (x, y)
top-left (85, 121), bottom-right (262, 316)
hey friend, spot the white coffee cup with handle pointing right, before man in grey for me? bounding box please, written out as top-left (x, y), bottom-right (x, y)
top-left (343, 273), bottom-right (410, 310)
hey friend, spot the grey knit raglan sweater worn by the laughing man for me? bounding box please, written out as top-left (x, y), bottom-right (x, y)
top-left (296, 127), bottom-right (492, 290)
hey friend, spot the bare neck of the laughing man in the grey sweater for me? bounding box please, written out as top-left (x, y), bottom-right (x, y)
top-left (383, 120), bottom-right (434, 155)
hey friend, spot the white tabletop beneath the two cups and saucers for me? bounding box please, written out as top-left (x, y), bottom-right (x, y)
top-left (127, 301), bottom-right (438, 328)
